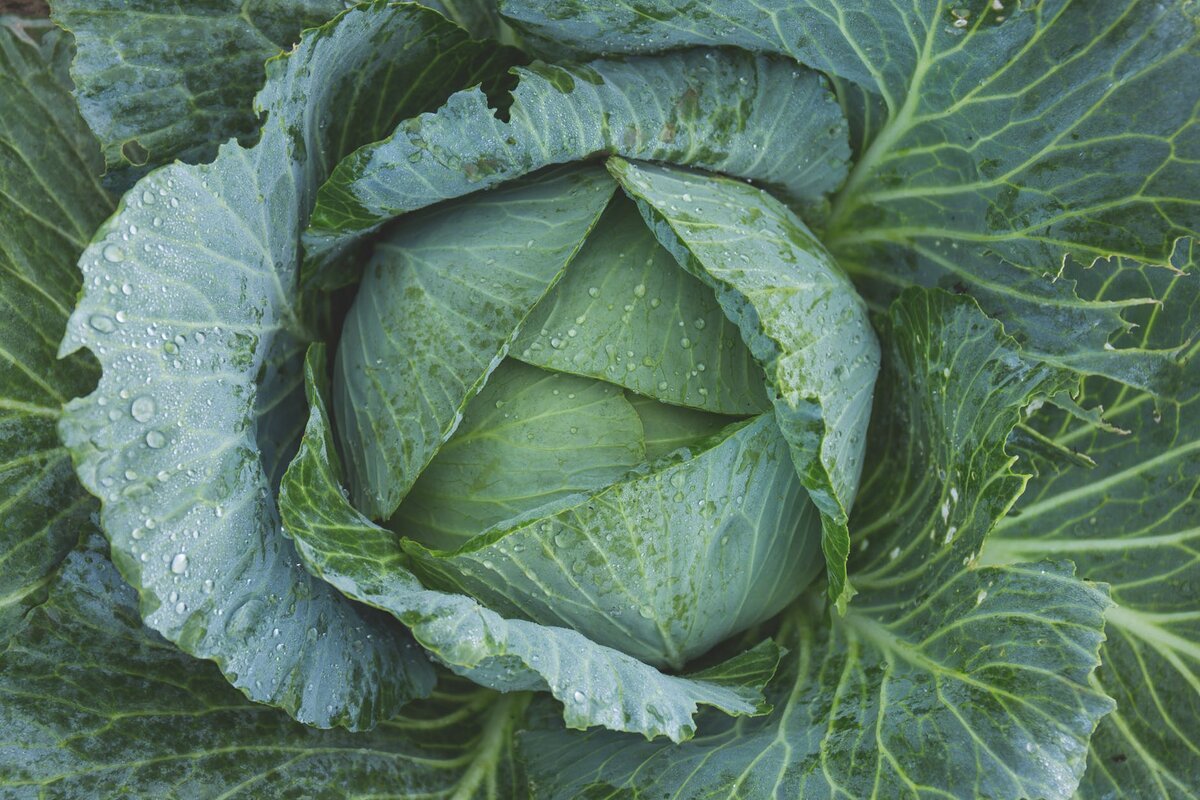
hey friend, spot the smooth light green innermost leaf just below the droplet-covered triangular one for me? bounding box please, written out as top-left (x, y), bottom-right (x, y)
top-left (388, 360), bottom-right (646, 551)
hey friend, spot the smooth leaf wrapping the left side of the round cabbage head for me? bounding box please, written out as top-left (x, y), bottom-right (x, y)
top-left (334, 167), bottom-right (613, 519)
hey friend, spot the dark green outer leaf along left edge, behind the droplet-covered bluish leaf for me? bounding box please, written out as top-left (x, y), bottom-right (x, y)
top-left (0, 18), bottom-right (113, 644)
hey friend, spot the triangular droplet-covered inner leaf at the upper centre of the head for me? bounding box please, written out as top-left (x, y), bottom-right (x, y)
top-left (511, 196), bottom-right (770, 414)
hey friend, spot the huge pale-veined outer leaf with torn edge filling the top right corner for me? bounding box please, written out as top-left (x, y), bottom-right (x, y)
top-left (502, 0), bottom-right (1200, 393)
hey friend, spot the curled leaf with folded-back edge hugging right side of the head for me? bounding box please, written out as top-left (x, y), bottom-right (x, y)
top-left (608, 158), bottom-right (878, 609)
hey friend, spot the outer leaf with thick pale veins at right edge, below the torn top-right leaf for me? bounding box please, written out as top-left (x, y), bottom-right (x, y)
top-left (984, 242), bottom-right (1200, 798)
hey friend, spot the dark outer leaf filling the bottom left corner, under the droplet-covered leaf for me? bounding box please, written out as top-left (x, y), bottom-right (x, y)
top-left (0, 541), bottom-right (528, 800)
